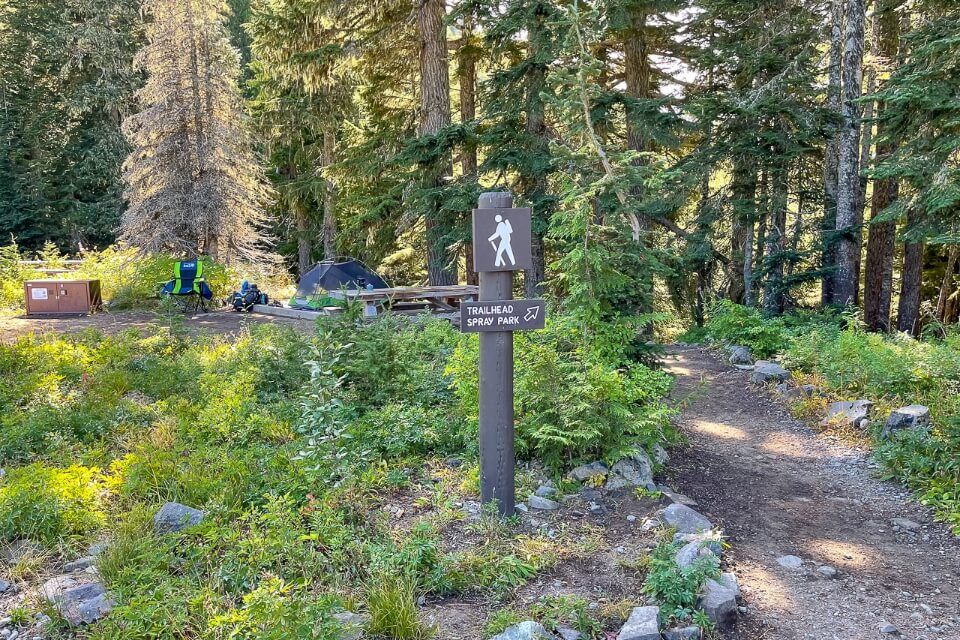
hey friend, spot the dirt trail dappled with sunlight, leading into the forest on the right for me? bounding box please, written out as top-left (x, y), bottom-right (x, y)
top-left (666, 346), bottom-right (960, 640)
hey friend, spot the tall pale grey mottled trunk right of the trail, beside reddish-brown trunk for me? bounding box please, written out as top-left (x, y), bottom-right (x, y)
top-left (833, 0), bottom-right (867, 305)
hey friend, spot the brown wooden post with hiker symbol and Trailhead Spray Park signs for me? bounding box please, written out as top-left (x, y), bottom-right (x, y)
top-left (460, 193), bottom-right (546, 515)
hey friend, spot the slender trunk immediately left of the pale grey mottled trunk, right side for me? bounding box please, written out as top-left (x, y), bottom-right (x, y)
top-left (820, 0), bottom-right (845, 305)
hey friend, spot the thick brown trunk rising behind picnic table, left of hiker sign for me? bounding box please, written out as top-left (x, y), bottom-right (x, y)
top-left (417, 0), bottom-right (457, 286)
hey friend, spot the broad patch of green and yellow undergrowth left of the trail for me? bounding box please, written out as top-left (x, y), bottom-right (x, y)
top-left (0, 314), bottom-right (676, 640)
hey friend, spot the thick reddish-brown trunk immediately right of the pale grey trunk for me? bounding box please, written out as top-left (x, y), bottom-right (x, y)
top-left (863, 5), bottom-right (900, 331)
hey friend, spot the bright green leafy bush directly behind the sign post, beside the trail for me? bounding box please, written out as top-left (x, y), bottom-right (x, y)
top-left (449, 317), bottom-right (675, 469)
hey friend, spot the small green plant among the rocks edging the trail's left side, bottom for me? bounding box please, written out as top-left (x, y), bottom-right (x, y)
top-left (643, 542), bottom-right (720, 620)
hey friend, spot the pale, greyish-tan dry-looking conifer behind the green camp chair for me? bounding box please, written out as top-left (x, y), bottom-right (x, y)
top-left (123, 0), bottom-right (269, 261)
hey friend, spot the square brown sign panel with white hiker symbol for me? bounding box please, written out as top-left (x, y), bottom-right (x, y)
top-left (473, 209), bottom-right (533, 273)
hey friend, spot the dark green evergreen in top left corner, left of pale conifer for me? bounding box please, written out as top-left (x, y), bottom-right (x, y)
top-left (0, 0), bottom-right (141, 250)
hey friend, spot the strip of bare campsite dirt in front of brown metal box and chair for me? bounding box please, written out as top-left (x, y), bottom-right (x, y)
top-left (0, 311), bottom-right (314, 343)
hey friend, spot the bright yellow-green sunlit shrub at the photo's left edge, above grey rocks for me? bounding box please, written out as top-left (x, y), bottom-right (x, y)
top-left (0, 464), bottom-right (105, 546)
